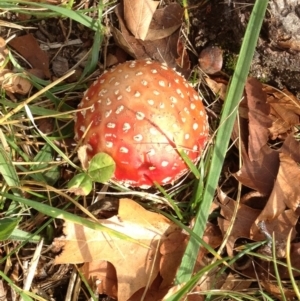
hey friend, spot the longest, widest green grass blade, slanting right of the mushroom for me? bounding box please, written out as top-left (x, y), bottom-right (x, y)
top-left (175, 0), bottom-right (268, 284)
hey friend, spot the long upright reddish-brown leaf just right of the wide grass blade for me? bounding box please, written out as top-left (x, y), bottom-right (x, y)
top-left (234, 78), bottom-right (279, 195)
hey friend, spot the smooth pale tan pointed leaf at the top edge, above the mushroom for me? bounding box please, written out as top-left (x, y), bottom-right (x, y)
top-left (124, 0), bottom-right (159, 40)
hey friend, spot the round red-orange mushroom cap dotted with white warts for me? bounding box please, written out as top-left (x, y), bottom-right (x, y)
top-left (75, 60), bottom-right (208, 188)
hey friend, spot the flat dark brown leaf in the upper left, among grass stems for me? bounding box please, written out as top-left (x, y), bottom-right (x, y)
top-left (9, 34), bottom-right (50, 78)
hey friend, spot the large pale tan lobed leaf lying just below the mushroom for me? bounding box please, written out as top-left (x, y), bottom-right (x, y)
top-left (54, 199), bottom-right (178, 301)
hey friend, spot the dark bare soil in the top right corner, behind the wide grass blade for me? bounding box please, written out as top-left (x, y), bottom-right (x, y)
top-left (190, 0), bottom-right (300, 97)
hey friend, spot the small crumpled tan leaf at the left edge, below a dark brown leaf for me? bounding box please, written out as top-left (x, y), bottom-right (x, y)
top-left (0, 69), bottom-right (32, 95)
